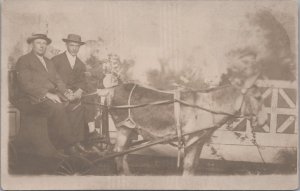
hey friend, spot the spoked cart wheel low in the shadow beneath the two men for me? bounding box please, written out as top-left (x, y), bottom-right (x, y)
top-left (56, 156), bottom-right (93, 175)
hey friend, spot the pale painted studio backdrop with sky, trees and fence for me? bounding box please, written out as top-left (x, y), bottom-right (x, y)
top-left (2, 0), bottom-right (298, 176)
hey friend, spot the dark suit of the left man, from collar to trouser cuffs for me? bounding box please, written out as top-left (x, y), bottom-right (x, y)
top-left (14, 52), bottom-right (78, 156)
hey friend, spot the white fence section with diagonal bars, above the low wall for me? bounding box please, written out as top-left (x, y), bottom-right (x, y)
top-left (218, 80), bottom-right (298, 134)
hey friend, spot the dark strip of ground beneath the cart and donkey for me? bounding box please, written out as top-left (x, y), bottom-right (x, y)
top-left (10, 154), bottom-right (297, 176)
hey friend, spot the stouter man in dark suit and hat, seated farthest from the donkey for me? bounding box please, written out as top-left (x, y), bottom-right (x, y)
top-left (15, 34), bottom-right (82, 156)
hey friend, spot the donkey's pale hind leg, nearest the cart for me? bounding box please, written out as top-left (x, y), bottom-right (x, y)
top-left (115, 127), bottom-right (132, 175)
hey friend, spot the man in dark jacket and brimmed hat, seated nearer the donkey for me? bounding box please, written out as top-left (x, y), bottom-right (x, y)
top-left (52, 34), bottom-right (109, 150)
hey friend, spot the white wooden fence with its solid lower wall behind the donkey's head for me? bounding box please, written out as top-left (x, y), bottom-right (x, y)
top-left (203, 80), bottom-right (298, 163)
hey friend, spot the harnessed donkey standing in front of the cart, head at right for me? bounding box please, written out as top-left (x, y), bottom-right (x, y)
top-left (111, 76), bottom-right (267, 175)
